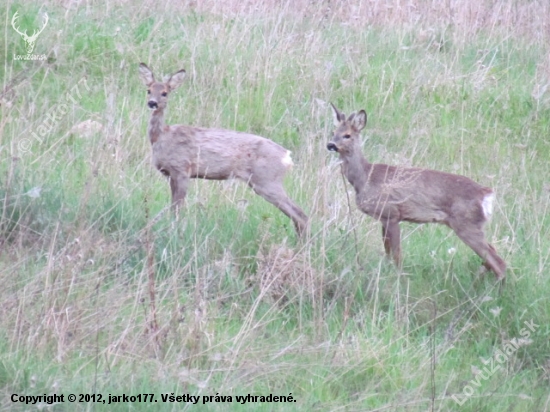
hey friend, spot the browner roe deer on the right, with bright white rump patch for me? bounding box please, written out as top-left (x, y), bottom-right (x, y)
top-left (327, 104), bottom-right (506, 281)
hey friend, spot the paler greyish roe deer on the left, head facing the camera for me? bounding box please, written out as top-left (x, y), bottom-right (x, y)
top-left (139, 63), bottom-right (308, 236)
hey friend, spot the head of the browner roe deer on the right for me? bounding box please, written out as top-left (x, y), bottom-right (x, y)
top-left (327, 103), bottom-right (367, 155)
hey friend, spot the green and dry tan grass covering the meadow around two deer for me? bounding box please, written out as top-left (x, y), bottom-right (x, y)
top-left (0, 0), bottom-right (550, 411)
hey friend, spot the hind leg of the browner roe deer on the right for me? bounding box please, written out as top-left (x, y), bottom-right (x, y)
top-left (451, 225), bottom-right (506, 281)
